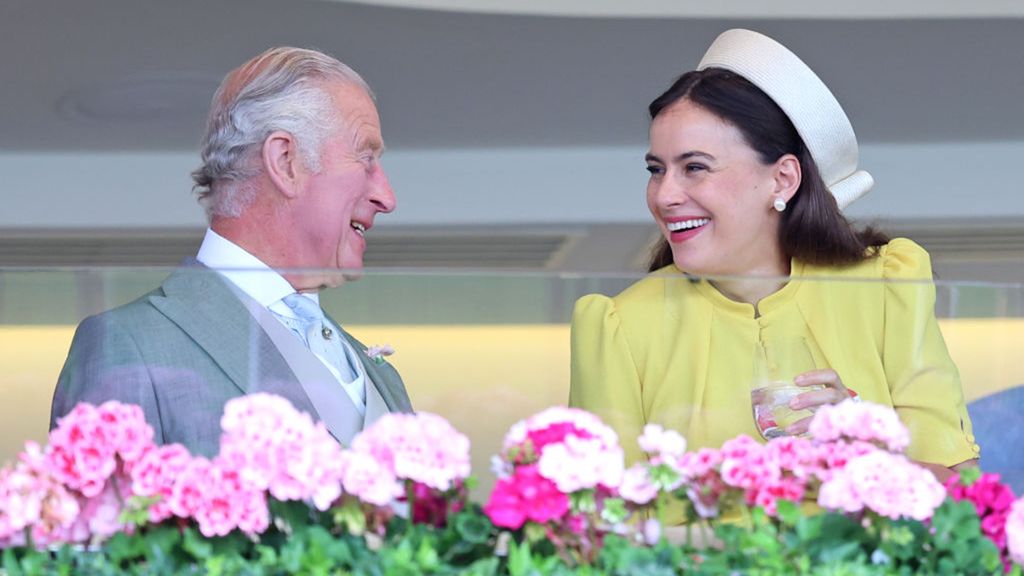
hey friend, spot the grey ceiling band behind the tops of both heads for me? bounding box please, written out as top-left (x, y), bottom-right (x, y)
top-left (0, 0), bottom-right (1024, 152)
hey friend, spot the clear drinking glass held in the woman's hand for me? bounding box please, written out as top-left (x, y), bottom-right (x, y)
top-left (751, 337), bottom-right (824, 440)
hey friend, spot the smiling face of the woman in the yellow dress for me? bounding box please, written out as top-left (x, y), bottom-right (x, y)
top-left (647, 99), bottom-right (799, 276)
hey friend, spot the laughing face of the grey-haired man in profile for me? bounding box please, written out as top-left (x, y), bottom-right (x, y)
top-left (294, 83), bottom-right (395, 285)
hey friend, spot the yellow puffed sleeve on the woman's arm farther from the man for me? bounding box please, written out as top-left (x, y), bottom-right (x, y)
top-left (882, 238), bottom-right (979, 466)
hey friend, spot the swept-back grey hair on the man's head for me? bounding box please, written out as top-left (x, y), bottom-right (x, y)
top-left (191, 47), bottom-right (373, 218)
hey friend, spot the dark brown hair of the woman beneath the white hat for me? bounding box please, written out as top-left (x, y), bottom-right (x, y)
top-left (648, 68), bottom-right (889, 272)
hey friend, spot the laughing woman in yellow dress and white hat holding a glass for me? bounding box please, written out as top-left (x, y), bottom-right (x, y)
top-left (569, 30), bottom-right (979, 479)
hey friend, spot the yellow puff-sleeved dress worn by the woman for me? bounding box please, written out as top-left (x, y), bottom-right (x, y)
top-left (569, 239), bottom-right (979, 466)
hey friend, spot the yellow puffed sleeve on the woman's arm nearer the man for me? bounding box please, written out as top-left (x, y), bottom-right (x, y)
top-left (569, 294), bottom-right (644, 465)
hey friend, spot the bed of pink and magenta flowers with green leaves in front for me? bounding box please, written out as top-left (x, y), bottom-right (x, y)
top-left (0, 395), bottom-right (1024, 576)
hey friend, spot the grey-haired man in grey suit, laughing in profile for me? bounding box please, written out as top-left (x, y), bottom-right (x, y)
top-left (50, 48), bottom-right (412, 455)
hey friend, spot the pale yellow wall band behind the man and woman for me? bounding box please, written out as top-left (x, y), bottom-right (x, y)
top-left (0, 319), bottom-right (1024, 488)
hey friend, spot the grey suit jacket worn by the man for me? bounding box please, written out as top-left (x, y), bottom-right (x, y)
top-left (50, 266), bottom-right (412, 456)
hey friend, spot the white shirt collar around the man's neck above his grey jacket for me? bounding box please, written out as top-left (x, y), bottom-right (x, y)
top-left (196, 229), bottom-right (319, 306)
